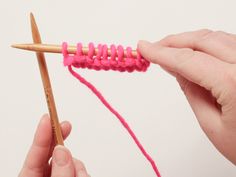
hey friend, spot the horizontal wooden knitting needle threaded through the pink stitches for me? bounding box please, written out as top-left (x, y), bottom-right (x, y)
top-left (12, 44), bottom-right (137, 57)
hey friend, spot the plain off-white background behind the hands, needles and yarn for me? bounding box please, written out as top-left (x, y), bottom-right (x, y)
top-left (0, 0), bottom-right (236, 177)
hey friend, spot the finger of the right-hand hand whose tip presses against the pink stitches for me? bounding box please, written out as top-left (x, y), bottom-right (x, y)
top-left (138, 41), bottom-right (226, 90)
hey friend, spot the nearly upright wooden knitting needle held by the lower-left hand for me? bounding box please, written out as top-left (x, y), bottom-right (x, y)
top-left (30, 13), bottom-right (64, 145)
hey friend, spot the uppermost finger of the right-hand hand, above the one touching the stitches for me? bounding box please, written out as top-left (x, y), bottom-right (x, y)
top-left (160, 29), bottom-right (236, 63)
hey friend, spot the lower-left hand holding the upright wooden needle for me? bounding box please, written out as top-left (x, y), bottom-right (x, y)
top-left (18, 115), bottom-right (89, 177)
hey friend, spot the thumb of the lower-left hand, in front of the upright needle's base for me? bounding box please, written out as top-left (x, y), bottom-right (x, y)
top-left (51, 145), bottom-right (75, 177)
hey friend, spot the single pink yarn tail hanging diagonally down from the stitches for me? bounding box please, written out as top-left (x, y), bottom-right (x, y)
top-left (68, 65), bottom-right (161, 177)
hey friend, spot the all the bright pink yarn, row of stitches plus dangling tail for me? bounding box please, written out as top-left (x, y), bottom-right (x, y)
top-left (62, 43), bottom-right (161, 177)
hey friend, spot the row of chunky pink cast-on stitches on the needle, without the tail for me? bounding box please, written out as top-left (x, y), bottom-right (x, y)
top-left (62, 42), bottom-right (150, 72)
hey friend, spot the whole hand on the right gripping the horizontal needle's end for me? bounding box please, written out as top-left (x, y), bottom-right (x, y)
top-left (138, 30), bottom-right (236, 165)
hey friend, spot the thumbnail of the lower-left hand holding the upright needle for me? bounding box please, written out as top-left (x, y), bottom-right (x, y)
top-left (53, 145), bottom-right (70, 166)
